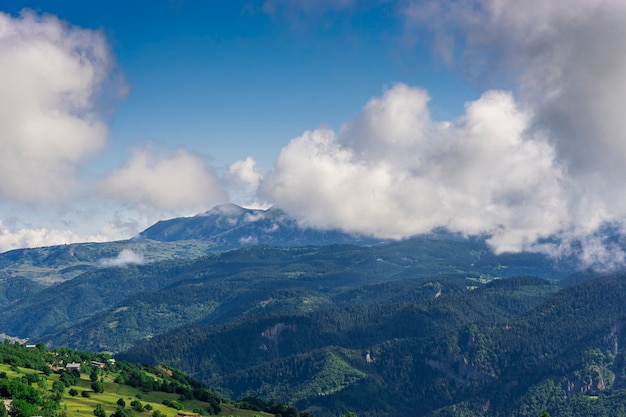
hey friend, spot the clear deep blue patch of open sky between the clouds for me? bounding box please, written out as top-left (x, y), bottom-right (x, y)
top-left (4, 0), bottom-right (470, 166)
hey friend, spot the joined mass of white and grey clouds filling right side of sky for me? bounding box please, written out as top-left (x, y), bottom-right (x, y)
top-left (261, 0), bottom-right (626, 265)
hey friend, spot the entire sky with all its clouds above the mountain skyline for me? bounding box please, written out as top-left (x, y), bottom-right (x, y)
top-left (0, 0), bottom-right (626, 269)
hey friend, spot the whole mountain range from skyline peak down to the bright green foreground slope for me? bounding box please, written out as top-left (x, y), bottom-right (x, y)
top-left (0, 205), bottom-right (626, 417)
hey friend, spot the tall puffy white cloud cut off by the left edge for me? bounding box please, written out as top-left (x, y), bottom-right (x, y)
top-left (0, 11), bottom-right (118, 203)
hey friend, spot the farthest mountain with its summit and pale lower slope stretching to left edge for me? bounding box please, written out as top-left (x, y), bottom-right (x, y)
top-left (0, 204), bottom-right (383, 288)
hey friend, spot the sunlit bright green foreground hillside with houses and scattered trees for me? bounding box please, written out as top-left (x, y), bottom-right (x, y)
top-left (0, 342), bottom-right (308, 417)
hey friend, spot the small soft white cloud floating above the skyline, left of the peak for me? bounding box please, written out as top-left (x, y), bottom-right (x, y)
top-left (98, 144), bottom-right (227, 212)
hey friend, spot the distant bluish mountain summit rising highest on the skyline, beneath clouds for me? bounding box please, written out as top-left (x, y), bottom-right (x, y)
top-left (140, 204), bottom-right (382, 251)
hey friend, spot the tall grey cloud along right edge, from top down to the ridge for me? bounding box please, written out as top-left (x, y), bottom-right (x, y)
top-left (390, 0), bottom-right (626, 264)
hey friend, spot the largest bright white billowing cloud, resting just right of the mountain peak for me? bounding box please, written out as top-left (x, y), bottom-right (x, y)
top-left (262, 84), bottom-right (567, 251)
